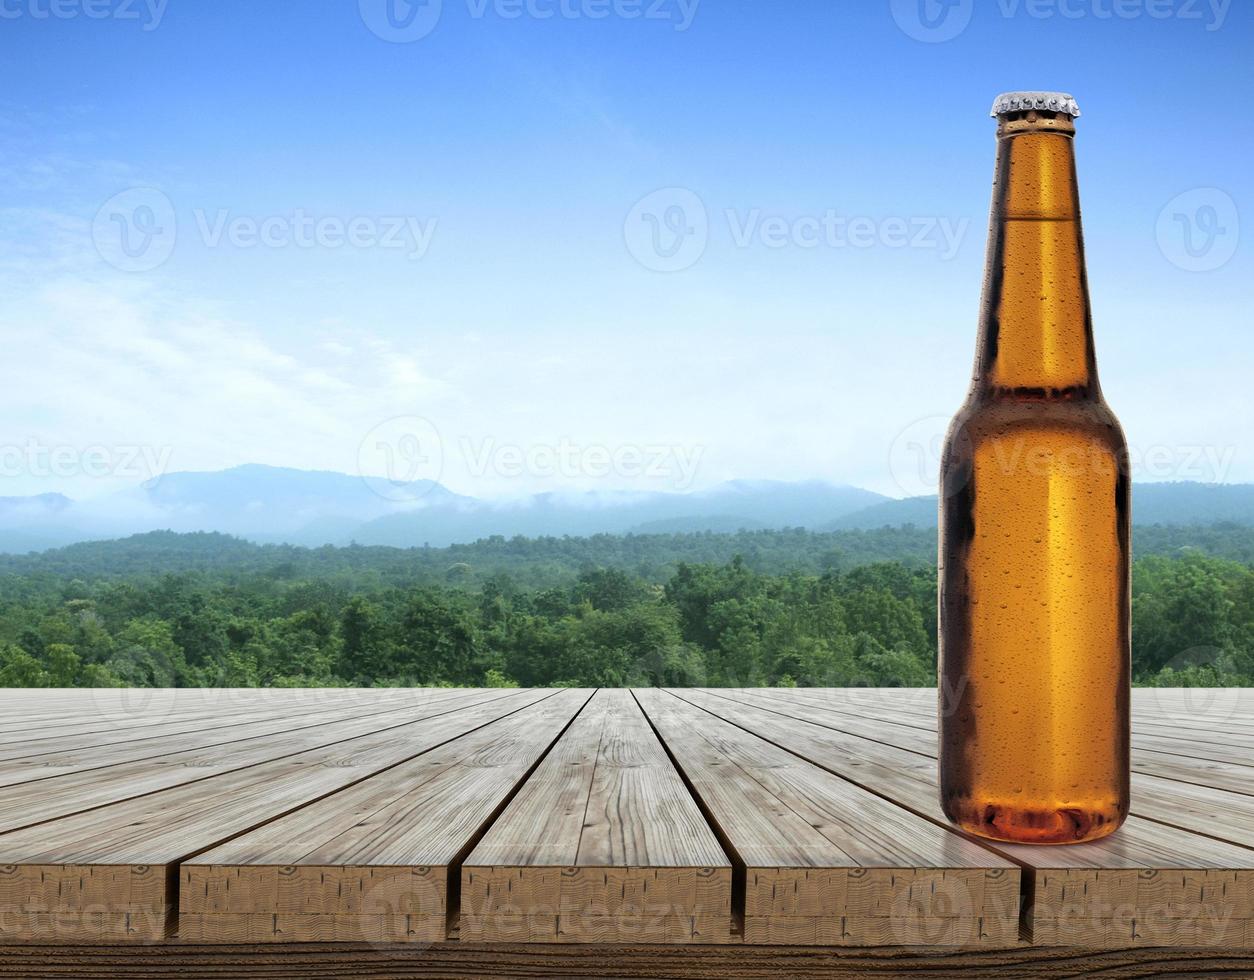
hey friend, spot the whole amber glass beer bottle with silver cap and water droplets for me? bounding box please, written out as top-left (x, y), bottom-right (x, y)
top-left (939, 93), bottom-right (1130, 843)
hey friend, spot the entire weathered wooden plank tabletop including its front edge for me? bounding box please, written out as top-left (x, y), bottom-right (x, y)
top-left (0, 689), bottom-right (1254, 977)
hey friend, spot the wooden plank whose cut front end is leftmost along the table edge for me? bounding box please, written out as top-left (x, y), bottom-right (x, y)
top-left (0, 690), bottom-right (553, 942)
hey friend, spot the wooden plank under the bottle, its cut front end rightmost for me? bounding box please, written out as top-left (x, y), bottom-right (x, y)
top-left (675, 690), bottom-right (1254, 947)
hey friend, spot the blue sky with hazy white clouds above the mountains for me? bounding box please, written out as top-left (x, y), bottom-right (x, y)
top-left (0, 0), bottom-right (1254, 496)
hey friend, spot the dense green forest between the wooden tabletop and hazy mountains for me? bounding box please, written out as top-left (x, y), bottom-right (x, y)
top-left (0, 525), bottom-right (1254, 688)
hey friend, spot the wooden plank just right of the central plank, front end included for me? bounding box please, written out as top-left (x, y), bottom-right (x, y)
top-left (635, 690), bottom-right (1020, 946)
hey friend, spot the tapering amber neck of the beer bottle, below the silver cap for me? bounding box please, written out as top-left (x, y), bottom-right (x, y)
top-left (974, 117), bottom-right (1100, 400)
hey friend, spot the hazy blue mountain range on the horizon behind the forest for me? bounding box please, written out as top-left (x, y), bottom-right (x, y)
top-left (0, 464), bottom-right (1254, 552)
